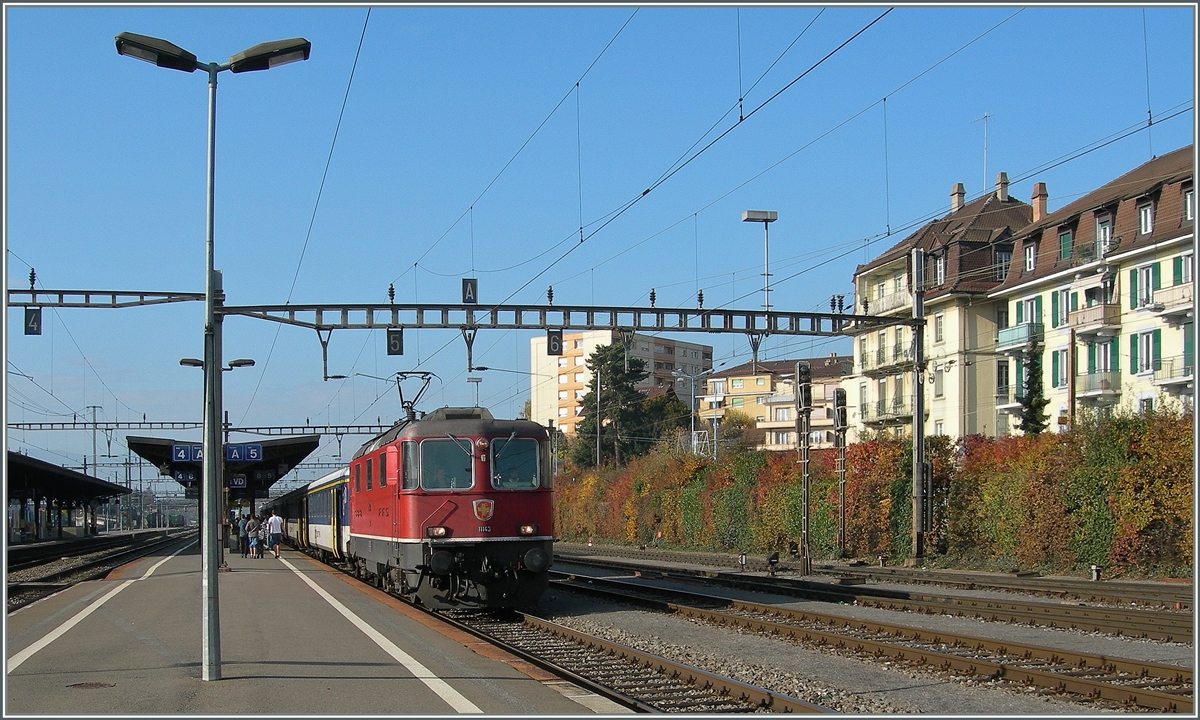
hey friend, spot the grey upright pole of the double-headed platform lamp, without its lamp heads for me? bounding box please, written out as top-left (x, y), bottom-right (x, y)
top-left (200, 62), bottom-right (222, 680)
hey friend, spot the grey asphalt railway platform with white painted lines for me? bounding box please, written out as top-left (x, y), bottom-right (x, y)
top-left (5, 539), bottom-right (629, 716)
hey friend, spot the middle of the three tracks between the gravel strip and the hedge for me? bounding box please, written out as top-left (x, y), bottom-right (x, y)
top-left (556, 553), bottom-right (1193, 643)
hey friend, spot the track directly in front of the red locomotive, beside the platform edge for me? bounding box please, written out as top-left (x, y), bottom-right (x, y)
top-left (434, 612), bottom-right (833, 714)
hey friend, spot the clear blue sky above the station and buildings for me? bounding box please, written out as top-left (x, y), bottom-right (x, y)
top-left (5, 6), bottom-right (1195, 487)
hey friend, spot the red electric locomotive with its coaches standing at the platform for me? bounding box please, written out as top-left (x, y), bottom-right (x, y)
top-left (262, 407), bottom-right (554, 610)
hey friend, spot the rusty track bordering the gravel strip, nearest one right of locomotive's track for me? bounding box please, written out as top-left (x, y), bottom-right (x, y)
top-left (552, 572), bottom-right (1193, 714)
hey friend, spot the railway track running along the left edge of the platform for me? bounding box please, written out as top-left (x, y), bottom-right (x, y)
top-left (6, 530), bottom-right (197, 613)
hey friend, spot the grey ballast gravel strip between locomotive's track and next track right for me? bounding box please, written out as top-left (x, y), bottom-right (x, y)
top-left (539, 590), bottom-right (1129, 716)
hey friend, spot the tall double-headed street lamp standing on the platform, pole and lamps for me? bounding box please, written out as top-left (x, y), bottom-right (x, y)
top-left (116, 32), bottom-right (312, 680)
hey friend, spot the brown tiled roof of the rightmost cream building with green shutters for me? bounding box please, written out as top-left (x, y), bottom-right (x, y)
top-left (995, 145), bottom-right (1194, 292)
